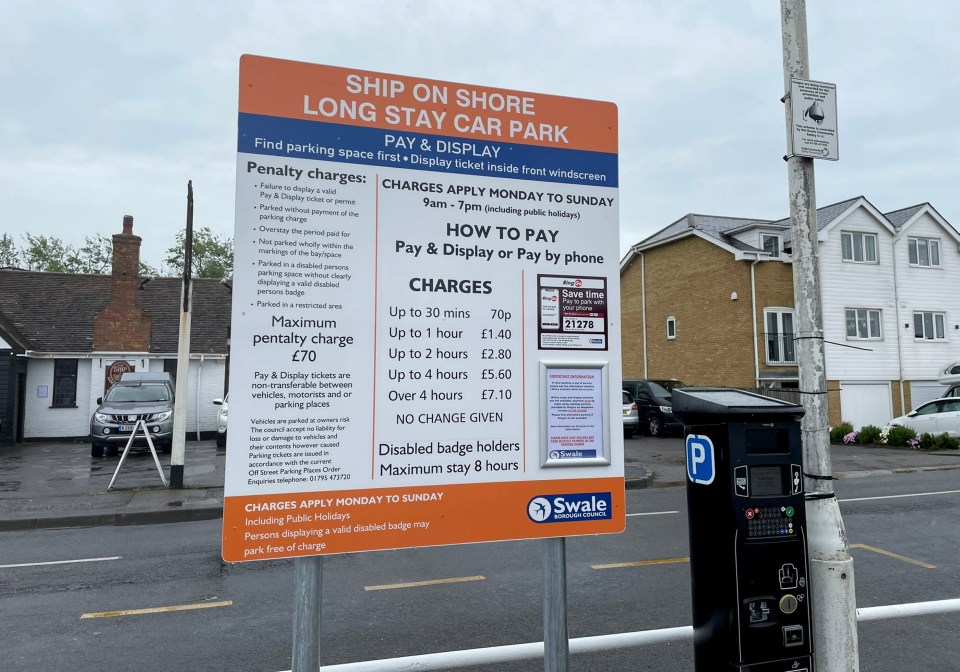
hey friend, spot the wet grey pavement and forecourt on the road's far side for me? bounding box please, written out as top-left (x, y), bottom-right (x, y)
top-left (0, 436), bottom-right (960, 531)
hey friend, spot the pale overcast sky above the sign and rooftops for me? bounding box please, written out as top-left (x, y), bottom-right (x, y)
top-left (0, 0), bottom-right (960, 265)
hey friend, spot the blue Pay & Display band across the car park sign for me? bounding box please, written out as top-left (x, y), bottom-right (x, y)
top-left (237, 114), bottom-right (618, 186)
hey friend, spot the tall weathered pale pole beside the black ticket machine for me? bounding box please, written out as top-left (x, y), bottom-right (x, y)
top-left (780, 0), bottom-right (860, 672)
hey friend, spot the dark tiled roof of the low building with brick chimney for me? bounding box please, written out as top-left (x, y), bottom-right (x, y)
top-left (0, 269), bottom-right (231, 354)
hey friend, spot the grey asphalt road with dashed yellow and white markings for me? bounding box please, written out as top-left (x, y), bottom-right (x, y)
top-left (0, 471), bottom-right (960, 672)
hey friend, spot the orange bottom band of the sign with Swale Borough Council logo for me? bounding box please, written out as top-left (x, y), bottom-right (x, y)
top-left (223, 477), bottom-right (626, 562)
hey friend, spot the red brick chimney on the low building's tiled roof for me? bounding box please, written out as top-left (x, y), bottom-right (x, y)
top-left (93, 215), bottom-right (151, 352)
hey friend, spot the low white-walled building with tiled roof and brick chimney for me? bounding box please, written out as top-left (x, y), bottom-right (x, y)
top-left (0, 217), bottom-right (231, 445)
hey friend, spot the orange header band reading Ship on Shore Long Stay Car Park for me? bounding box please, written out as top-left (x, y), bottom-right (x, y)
top-left (240, 55), bottom-right (617, 154)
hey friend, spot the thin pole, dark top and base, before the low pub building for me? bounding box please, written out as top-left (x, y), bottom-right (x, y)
top-left (170, 180), bottom-right (199, 490)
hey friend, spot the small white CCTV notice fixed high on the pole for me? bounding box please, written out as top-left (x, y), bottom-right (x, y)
top-left (788, 77), bottom-right (840, 161)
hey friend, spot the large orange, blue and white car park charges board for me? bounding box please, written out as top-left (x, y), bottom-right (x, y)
top-left (223, 56), bottom-right (625, 561)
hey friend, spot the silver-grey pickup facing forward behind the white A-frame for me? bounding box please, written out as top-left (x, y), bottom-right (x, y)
top-left (90, 371), bottom-right (175, 457)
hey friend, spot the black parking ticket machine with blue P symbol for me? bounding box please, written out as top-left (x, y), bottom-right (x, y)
top-left (673, 388), bottom-right (813, 672)
